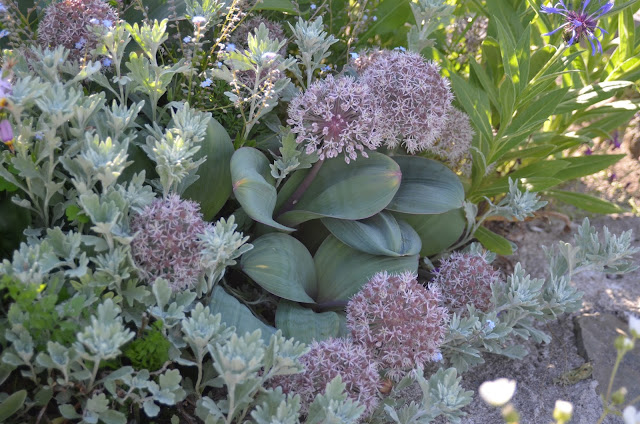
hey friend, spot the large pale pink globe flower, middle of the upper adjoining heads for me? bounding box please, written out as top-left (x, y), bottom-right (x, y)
top-left (361, 51), bottom-right (453, 153)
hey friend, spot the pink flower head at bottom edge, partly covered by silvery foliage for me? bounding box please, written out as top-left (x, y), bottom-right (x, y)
top-left (271, 339), bottom-right (380, 416)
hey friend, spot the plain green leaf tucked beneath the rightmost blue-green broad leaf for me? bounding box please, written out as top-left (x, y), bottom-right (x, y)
top-left (395, 209), bottom-right (467, 256)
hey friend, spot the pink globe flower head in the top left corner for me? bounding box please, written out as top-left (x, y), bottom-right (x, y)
top-left (38, 0), bottom-right (118, 60)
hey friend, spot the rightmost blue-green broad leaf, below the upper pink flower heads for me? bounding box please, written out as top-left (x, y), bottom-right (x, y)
top-left (387, 156), bottom-right (464, 215)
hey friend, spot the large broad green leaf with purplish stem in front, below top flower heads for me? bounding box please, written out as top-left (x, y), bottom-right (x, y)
top-left (278, 152), bottom-right (401, 226)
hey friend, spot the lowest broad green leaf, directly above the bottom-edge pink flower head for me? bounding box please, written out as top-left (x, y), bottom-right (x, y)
top-left (276, 300), bottom-right (340, 344)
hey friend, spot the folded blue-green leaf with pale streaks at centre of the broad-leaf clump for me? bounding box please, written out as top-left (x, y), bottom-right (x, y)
top-left (322, 211), bottom-right (422, 256)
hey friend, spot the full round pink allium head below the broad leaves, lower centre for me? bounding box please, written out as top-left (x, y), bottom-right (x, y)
top-left (347, 272), bottom-right (448, 380)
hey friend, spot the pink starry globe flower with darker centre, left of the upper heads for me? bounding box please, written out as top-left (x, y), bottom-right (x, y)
top-left (287, 75), bottom-right (381, 163)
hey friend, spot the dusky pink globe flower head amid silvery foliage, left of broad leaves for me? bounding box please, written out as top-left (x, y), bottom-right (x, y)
top-left (131, 194), bottom-right (206, 291)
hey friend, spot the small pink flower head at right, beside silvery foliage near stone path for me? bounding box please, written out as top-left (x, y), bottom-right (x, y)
top-left (432, 252), bottom-right (500, 313)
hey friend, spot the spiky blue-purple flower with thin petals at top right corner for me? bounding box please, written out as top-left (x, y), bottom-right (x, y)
top-left (540, 0), bottom-right (613, 56)
